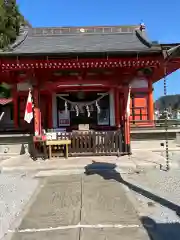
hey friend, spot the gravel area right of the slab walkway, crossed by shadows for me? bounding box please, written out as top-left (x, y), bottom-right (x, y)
top-left (123, 169), bottom-right (180, 240)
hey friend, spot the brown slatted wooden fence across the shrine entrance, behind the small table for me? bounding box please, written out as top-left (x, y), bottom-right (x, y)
top-left (46, 130), bottom-right (125, 156)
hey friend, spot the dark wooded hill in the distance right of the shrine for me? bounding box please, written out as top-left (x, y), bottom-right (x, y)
top-left (154, 94), bottom-right (180, 110)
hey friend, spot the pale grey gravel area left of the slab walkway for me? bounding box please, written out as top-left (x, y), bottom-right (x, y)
top-left (0, 174), bottom-right (38, 239)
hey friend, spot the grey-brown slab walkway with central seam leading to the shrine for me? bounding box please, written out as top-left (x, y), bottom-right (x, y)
top-left (9, 171), bottom-right (149, 240)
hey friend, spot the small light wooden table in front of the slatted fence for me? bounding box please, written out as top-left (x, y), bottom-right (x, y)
top-left (46, 140), bottom-right (71, 159)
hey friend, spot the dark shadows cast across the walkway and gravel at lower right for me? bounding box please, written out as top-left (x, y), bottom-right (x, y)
top-left (84, 161), bottom-right (180, 240)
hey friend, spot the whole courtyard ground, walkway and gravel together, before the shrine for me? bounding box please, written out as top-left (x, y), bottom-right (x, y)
top-left (0, 151), bottom-right (180, 240)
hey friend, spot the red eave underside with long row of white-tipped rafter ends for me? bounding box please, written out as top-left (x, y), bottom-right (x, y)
top-left (1, 56), bottom-right (161, 71)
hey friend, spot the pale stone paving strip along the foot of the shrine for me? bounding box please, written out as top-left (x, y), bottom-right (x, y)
top-left (0, 150), bottom-right (180, 174)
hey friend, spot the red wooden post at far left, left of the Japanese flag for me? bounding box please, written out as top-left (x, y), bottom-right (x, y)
top-left (12, 83), bottom-right (19, 128)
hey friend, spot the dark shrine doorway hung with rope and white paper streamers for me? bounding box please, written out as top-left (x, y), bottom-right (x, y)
top-left (56, 91), bottom-right (110, 131)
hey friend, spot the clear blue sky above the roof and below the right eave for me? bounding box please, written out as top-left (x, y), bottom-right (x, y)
top-left (17, 0), bottom-right (180, 99)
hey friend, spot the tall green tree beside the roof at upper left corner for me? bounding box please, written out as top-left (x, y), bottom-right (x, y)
top-left (0, 0), bottom-right (24, 49)
